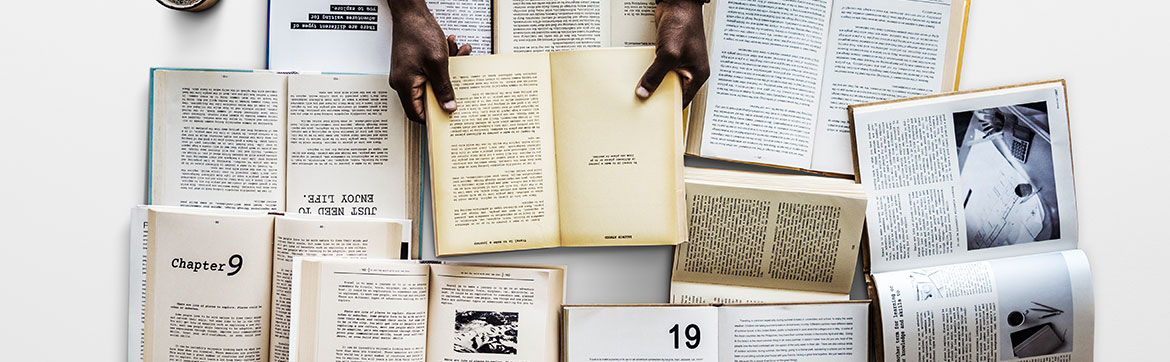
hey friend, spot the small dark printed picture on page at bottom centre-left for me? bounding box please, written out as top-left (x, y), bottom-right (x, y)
top-left (455, 310), bottom-right (519, 355)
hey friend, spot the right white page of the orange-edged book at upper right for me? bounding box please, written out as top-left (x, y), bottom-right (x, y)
top-left (811, 0), bottom-right (954, 175)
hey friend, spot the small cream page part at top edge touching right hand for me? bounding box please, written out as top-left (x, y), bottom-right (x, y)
top-left (608, 0), bottom-right (658, 48)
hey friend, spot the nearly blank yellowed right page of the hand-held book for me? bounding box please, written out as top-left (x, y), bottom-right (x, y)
top-left (551, 47), bottom-right (686, 246)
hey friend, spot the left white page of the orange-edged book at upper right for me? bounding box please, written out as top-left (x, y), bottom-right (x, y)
top-left (696, 0), bottom-right (831, 169)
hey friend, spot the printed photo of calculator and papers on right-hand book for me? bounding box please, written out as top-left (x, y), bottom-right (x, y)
top-left (954, 102), bottom-right (1060, 251)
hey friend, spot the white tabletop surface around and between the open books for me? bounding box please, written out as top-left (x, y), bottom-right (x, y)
top-left (0, 0), bottom-right (1170, 361)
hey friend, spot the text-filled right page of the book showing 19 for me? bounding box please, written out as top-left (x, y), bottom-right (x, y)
top-left (718, 302), bottom-right (870, 362)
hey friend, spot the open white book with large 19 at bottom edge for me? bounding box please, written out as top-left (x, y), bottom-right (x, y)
top-left (561, 300), bottom-right (869, 362)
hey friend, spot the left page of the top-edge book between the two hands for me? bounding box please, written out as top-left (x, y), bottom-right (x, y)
top-left (495, 0), bottom-right (613, 52)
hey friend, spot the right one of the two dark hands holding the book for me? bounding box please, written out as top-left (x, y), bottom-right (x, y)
top-left (634, 0), bottom-right (711, 108)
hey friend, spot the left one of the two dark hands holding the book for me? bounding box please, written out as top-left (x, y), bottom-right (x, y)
top-left (387, 0), bottom-right (472, 123)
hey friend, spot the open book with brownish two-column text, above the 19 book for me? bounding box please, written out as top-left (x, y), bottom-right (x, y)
top-left (670, 168), bottom-right (866, 303)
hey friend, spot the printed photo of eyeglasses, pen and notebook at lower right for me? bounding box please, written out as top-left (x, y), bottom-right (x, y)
top-left (991, 253), bottom-right (1073, 361)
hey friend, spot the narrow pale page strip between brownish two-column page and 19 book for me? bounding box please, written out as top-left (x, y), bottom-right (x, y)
top-left (670, 281), bottom-right (849, 305)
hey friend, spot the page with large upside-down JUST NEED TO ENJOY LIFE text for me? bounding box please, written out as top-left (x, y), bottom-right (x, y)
top-left (285, 75), bottom-right (411, 219)
